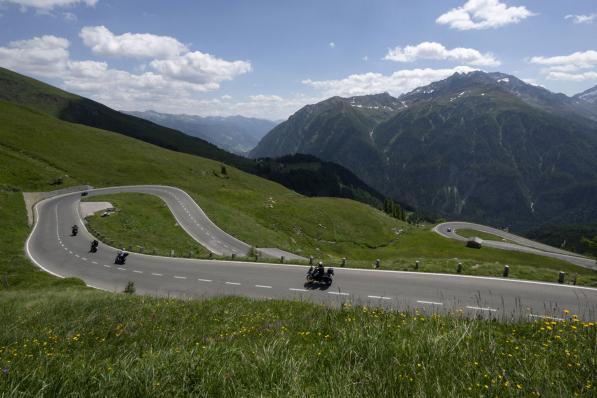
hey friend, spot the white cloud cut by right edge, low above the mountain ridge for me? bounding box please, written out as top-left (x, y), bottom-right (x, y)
top-left (530, 50), bottom-right (597, 81)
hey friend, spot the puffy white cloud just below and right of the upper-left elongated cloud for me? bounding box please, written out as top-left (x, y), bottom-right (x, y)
top-left (150, 51), bottom-right (251, 86)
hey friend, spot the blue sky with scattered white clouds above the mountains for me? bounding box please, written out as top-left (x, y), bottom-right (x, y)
top-left (0, 0), bottom-right (597, 119)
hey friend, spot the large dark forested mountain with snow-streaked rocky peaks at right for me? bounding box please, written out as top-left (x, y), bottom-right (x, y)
top-left (250, 72), bottom-right (597, 229)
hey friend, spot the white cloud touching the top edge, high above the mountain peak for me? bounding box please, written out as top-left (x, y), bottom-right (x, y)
top-left (435, 0), bottom-right (534, 30)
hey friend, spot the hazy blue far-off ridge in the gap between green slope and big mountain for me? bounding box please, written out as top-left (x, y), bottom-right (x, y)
top-left (124, 111), bottom-right (277, 155)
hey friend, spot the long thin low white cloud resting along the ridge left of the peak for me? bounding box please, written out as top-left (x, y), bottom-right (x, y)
top-left (303, 66), bottom-right (476, 97)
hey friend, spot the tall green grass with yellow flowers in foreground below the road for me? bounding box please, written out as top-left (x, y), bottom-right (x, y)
top-left (0, 288), bottom-right (597, 397)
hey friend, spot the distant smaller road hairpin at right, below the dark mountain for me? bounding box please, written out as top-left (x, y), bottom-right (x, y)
top-left (433, 221), bottom-right (597, 270)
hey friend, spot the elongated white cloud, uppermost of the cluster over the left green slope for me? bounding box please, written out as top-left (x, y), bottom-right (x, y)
top-left (79, 26), bottom-right (188, 58)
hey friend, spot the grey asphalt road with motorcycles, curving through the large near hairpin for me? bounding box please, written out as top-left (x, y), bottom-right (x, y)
top-left (26, 186), bottom-right (597, 320)
